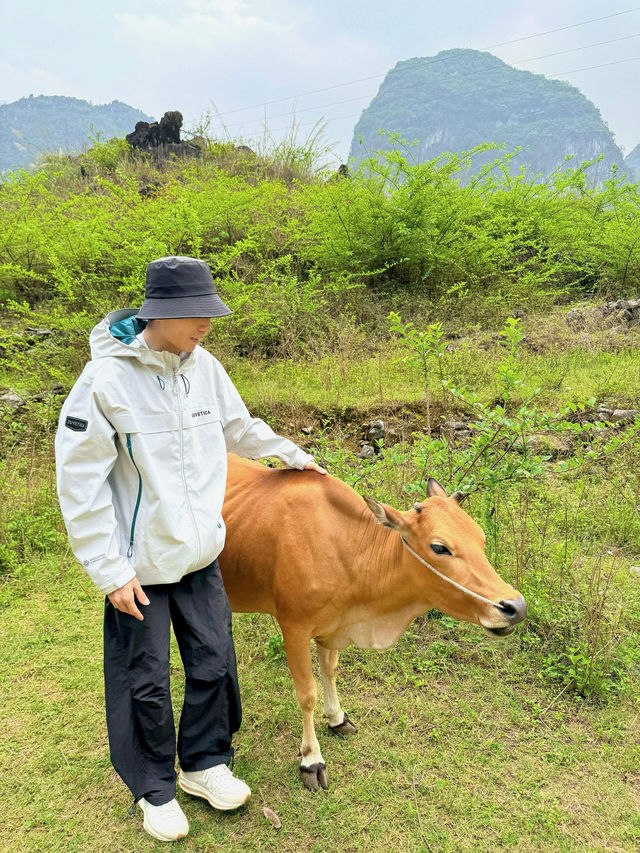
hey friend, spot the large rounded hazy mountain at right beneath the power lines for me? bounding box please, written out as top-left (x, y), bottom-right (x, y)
top-left (349, 49), bottom-right (624, 181)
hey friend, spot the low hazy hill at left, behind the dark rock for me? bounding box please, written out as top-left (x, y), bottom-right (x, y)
top-left (0, 95), bottom-right (154, 172)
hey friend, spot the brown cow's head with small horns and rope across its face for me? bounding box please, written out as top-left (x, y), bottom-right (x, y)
top-left (364, 477), bottom-right (527, 636)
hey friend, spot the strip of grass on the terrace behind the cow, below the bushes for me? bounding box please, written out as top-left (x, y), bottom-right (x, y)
top-left (226, 309), bottom-right (640, 412)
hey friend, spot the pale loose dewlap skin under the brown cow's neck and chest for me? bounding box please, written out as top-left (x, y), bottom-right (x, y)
top-left (315, 602), bottom-right (429, 649)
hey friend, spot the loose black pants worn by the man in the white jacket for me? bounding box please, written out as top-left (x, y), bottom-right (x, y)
top-left (104, 560), bottom-right (242, 806)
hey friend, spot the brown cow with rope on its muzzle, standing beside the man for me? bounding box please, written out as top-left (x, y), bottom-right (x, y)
top-left (219, 454), bottom-right (526, 790)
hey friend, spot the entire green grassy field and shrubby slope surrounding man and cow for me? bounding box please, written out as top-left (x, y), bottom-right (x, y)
top-left (0, 128), bottom-right (640, 853)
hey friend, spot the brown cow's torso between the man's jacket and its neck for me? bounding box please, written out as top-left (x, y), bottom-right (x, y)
top-left (219, 453), bottom-right (368, 617)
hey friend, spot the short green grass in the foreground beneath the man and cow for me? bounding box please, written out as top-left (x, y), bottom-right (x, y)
top-left (0, 554), bottom-right (640, 853)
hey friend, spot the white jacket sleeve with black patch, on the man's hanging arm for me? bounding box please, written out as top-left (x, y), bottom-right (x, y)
top-left (55, 368), bottom-right (135, 595)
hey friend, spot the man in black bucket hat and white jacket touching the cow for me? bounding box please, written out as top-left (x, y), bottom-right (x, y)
top-left (55, 256), bottom-right (326, 841)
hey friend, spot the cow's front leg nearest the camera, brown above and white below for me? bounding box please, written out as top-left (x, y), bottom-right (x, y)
top-left (280, 625), bottom-right (329, 791)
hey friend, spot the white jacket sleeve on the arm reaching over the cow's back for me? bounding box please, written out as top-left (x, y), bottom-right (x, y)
top-left (215, 359), bottom-right (313, 469)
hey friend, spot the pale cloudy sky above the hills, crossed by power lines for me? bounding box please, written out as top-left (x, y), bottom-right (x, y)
top-left (0, 0), bottom-right (640, 161)
